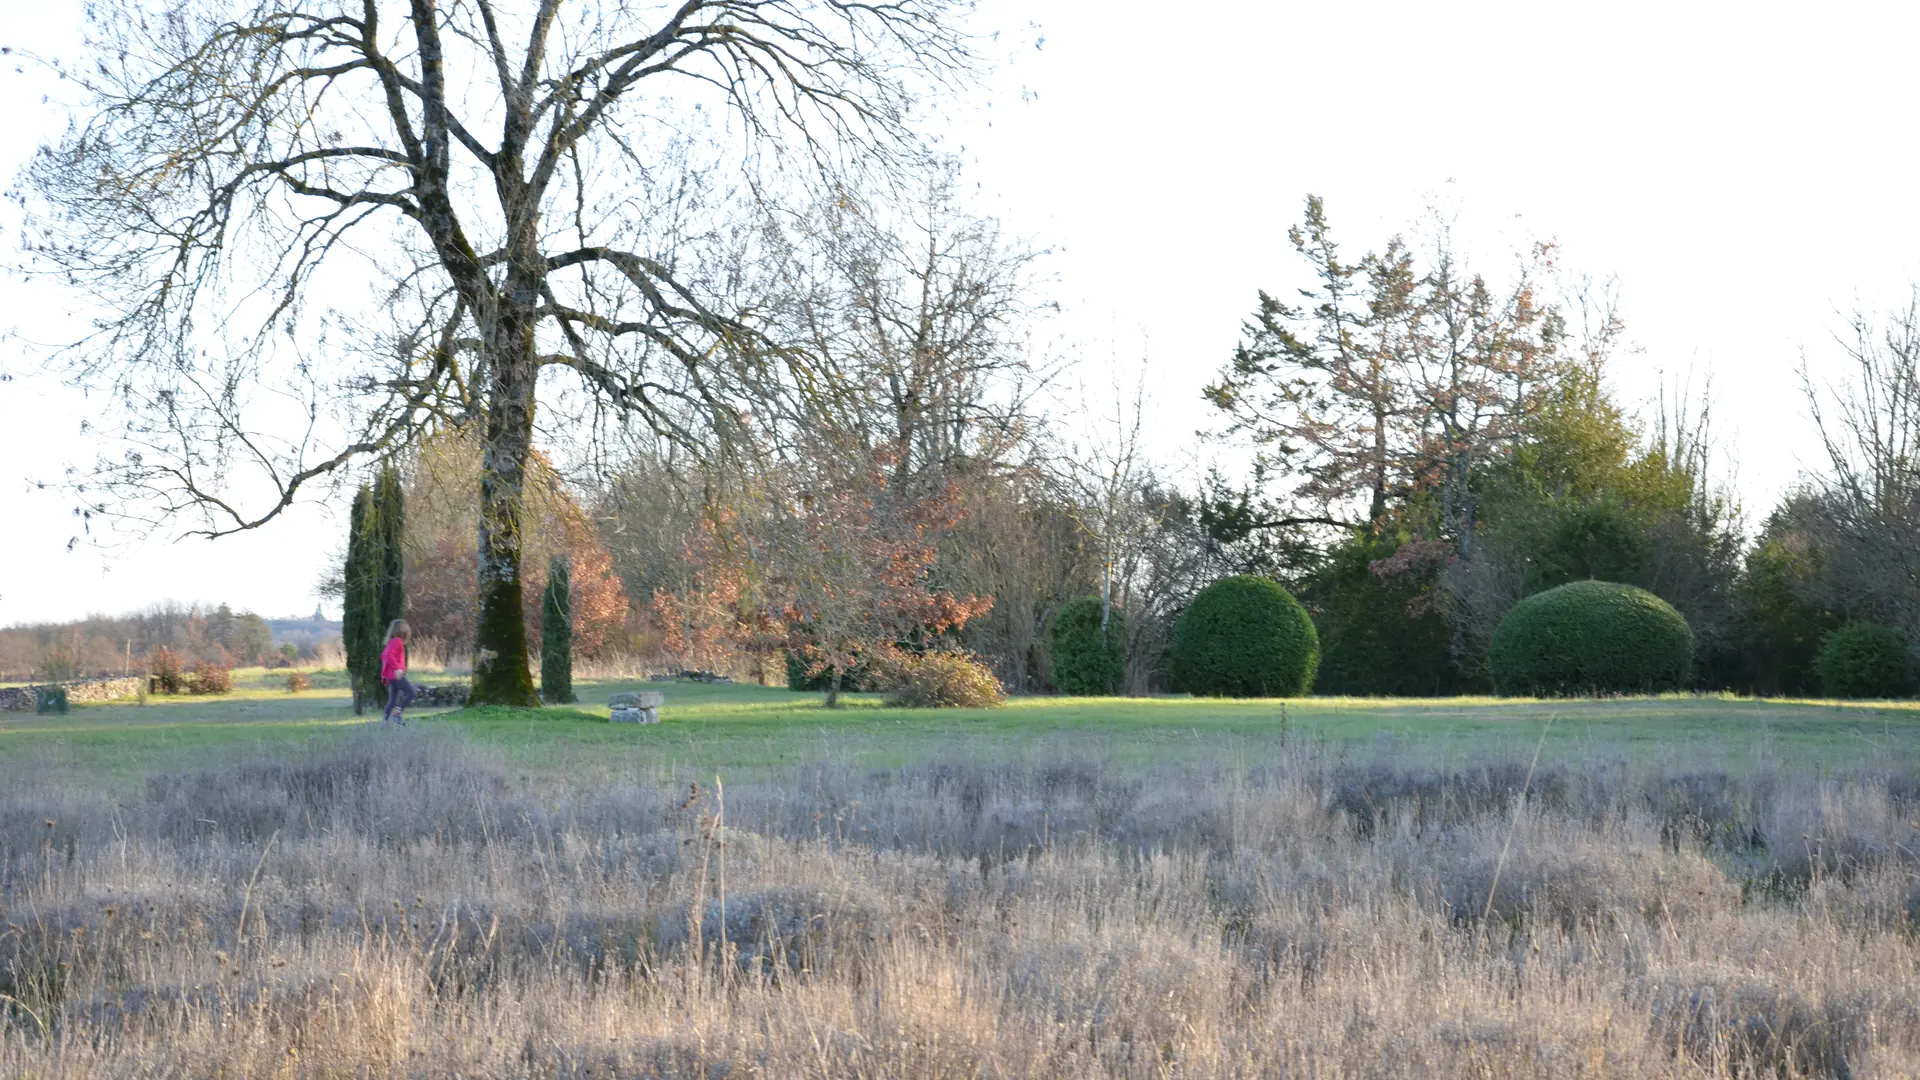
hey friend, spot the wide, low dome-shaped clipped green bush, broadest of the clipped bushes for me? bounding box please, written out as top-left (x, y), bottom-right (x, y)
top-left (1486, 580), bottom-right (1693, 698)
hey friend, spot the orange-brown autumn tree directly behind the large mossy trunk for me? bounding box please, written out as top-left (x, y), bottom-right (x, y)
top-left (407, 430), bottom-right (628, 657)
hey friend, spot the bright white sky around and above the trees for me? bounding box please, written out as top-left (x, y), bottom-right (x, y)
top-left (0, 0), bottom-right (1920, 625)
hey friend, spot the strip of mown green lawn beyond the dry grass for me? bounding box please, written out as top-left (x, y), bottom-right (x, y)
top-left (0, 669), bottom-right (1920, 780)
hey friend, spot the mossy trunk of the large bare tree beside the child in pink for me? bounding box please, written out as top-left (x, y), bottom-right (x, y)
top-left (468, 325), bottom-right (540, 707)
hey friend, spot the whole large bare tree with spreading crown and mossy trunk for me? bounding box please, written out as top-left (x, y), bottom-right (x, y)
top-left (27, 0), bottom-right (970, 705)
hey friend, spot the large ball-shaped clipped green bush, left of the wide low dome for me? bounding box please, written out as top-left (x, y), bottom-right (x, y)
top-left (1167, 575), bottom-right (1319, 698)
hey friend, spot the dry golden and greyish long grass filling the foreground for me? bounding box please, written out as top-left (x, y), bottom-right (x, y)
top-left (0, 732), bottom-right (1920, 1078)
